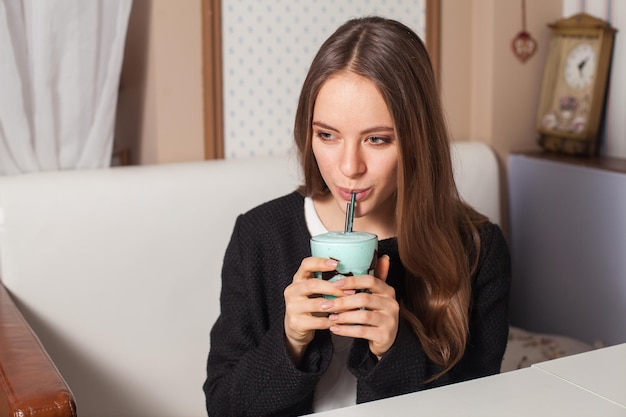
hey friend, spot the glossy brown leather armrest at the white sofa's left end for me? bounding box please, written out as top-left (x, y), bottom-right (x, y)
top-left (0, 282), bottom-right (76, 417)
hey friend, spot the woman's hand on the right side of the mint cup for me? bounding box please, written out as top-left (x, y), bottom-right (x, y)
top-left (322, 256), bottom-right (400, 359)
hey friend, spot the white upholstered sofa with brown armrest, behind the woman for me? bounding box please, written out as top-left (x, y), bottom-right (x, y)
top-left (0, 142), bottom-right (500, 417)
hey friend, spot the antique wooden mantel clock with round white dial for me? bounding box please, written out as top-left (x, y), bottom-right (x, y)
top-left (537, 13), bottom-right (616, 156)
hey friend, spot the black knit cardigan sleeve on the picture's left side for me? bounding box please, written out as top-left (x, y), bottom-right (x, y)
top-left (204, 210), bottom-right (332, 416)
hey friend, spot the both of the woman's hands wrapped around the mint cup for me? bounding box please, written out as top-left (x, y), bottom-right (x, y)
top-left (284, 252), bottom-right (400, 364)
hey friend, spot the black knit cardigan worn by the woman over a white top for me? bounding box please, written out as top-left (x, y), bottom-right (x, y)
top-left (204, 192), bottom-right (511, 417)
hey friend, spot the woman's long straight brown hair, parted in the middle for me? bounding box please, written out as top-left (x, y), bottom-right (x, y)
top-left (294, 17), bottom-right (484, 380)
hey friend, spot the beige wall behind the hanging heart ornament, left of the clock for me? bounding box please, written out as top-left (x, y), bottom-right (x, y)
top-left (441, 0), bottom-right (562, 232)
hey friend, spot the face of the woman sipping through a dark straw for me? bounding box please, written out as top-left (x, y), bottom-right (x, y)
top-left (312, 72), bottom-right (398, 228)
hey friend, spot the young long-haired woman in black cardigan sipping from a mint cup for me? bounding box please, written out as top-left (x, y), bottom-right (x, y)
top-left (204, 17), bottom-right (510, 416)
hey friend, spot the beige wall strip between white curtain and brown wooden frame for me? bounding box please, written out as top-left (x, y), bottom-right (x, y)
top-left (116, 0), bottom-right (204, 164)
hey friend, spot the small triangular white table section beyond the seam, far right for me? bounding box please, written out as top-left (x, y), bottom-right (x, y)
top-left (533, 343), bottom-right (626, 407)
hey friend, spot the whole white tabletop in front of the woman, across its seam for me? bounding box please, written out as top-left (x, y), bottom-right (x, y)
top-left (315, 344), bottom-right (626, 417)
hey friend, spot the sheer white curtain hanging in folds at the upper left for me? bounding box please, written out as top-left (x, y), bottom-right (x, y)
top-left (0, 0), bottom-right (132, 175)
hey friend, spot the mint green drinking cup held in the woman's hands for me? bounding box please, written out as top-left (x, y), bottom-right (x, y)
top-left (311, 232), bottom-right (378, 299)
